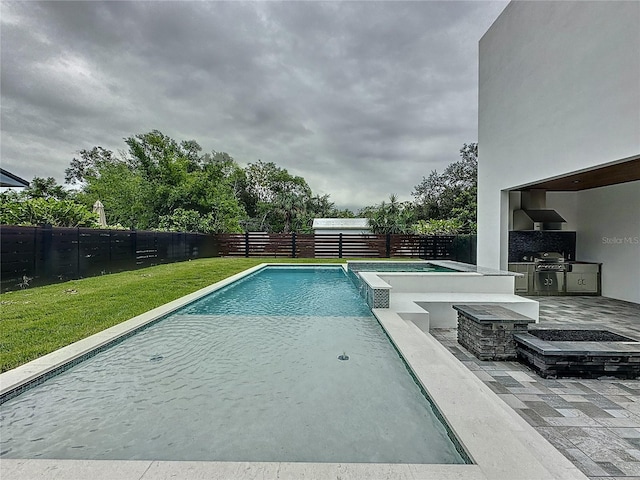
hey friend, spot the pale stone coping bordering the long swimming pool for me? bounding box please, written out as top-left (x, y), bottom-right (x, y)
top-left (0, 263), bottom-right (587, 480)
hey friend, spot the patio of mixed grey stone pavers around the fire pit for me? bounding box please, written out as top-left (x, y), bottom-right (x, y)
top-left (430, 296), bottom-right (640, 480)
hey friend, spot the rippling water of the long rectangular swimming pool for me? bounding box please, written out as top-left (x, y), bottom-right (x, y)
top-left (0, 267), bottom-right (464, 463)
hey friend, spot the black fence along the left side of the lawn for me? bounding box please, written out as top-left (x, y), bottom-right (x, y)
top-left (0, 225), bottom-right (218, 291)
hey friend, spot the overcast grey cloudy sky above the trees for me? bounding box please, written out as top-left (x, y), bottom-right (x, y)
top-left (0, 1), bottom-right (507, 209)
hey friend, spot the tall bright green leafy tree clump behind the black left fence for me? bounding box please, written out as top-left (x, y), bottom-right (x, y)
top-left (66, 130), bottom-right (245, 232)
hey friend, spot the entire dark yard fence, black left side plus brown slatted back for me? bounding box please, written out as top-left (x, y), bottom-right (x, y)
top-left (0, 226), bottom-right (476, 291)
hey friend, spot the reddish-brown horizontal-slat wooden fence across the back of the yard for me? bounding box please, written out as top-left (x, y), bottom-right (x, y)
top-left (216, 232), bottom-right (476, 264)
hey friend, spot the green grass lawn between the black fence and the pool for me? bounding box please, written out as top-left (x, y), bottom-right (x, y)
top-left (0, 258), bottom-right (384, 372)
